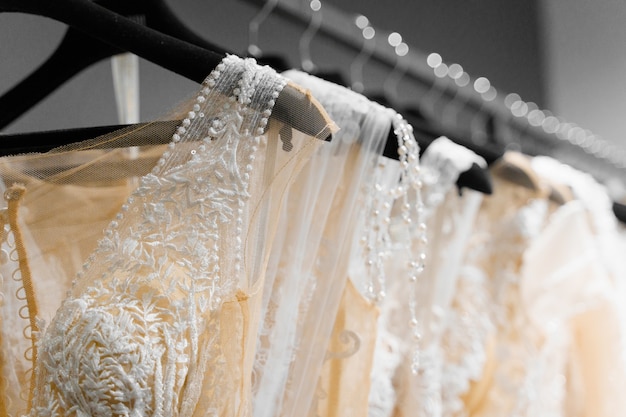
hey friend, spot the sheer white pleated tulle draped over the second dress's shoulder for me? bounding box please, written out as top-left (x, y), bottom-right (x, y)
top-left (255, 71), bottom-right (390, 416)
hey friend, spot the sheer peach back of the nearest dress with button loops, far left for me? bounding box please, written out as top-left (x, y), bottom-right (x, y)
top-left (0, 169), bottom-right (130, 416)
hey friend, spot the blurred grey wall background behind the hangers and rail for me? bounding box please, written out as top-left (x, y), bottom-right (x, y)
top-left (0, 0), bottom-right (626, 153)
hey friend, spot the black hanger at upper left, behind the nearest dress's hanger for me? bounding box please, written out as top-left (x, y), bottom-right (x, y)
top-left (0, 0), bottom-right (226, 129)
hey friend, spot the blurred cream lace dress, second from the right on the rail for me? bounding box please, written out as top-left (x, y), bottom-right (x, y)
top-left (456, 163), bottom-right (549, 417)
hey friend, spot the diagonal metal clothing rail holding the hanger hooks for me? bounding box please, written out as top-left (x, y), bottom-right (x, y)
top-left (247, 0), bottom-right (626, 186)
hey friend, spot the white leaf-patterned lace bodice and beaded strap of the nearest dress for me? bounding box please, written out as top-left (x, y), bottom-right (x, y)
top-left (30, 56), bottom-right (286, 416)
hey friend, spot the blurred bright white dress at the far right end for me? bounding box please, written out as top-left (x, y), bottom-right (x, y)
top-left (525, 157), bottom-right (626, 416)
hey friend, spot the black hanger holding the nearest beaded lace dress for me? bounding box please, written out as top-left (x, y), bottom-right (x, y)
top-left (0, 0), bottom-right (327, 149)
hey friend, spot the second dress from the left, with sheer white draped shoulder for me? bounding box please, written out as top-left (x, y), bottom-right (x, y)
top-left (255, 71), bottom-right (417, 416)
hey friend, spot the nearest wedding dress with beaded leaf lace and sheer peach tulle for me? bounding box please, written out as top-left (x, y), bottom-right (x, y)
top-left (1, 56), bottom-right (334, 416)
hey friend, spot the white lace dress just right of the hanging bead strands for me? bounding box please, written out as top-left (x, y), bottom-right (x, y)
top-left (376, 137), bottom-right (486, 416)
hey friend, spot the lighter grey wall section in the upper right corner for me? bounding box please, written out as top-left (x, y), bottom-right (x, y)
top-left (542, 0), bottom-right (626, 147)
